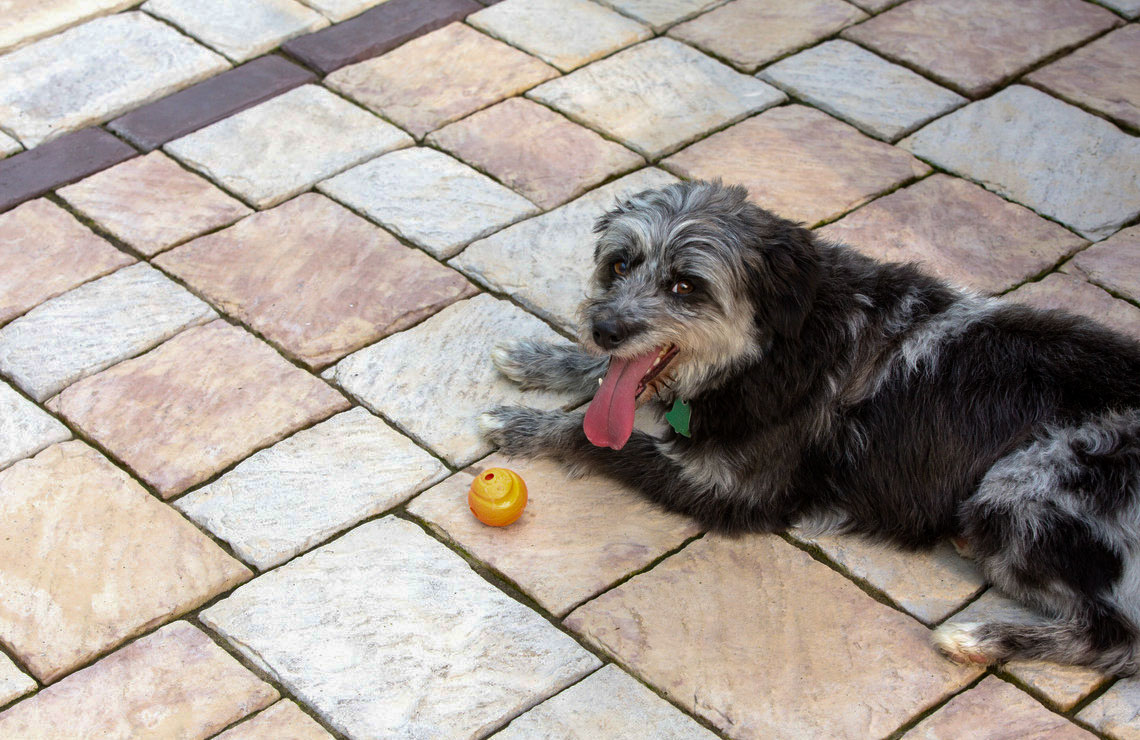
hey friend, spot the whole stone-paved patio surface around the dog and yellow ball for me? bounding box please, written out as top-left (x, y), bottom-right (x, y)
top-left (0, 0), bottom-right (1140, 740)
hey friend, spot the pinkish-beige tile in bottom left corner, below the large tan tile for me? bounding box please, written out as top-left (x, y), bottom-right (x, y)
top-left (0, 621), bottom-right (278, 740)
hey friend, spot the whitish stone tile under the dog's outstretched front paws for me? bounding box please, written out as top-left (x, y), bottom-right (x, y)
top-left (324, 295), bottom-right (573, 466)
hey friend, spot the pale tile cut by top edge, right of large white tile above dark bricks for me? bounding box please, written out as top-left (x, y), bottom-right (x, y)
top-left (143, 0), bottom-right (328, 62)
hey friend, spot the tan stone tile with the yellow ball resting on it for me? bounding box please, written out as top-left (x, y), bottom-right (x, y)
top-left (408, 455), bottom-right (700, 617)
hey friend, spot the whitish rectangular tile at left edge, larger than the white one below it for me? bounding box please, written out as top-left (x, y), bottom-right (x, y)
top-left (0, 263), bottom-right (218, 401)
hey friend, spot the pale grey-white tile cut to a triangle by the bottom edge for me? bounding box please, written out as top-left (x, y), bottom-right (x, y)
top-left (491, 665), bottom-right (716, 740)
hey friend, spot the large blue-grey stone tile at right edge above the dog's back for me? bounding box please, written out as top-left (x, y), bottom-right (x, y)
top-left (899, 86), bottom-right (1140, 241)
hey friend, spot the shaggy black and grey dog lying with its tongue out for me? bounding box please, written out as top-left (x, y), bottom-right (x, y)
top-left (480, 181), bottom-right (1140, 675)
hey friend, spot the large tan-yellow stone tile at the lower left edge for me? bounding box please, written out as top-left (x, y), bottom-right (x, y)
top-left (0, 441), bottom-right (251, 679)
